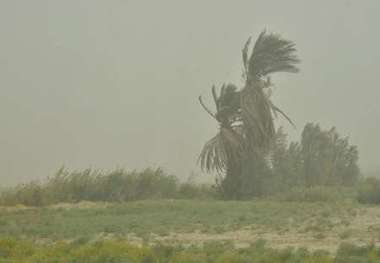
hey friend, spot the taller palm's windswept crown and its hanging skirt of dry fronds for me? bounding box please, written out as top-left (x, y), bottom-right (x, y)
top-left (240, 31), bottom-right (299, 152)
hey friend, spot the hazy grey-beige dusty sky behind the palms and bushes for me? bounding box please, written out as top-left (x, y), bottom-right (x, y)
top-left (0, 0), bottom-right (380, 184)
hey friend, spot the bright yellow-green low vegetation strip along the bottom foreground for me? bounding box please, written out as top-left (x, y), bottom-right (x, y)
top-left (0, 239), bottom-right (380, 263)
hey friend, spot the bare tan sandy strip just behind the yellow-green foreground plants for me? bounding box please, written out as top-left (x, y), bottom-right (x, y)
top-left (142, 207), bottom-right (380, 253)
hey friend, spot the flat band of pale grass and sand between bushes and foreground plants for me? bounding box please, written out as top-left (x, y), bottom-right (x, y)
top-left (0, 200), bottom-right (380, 253)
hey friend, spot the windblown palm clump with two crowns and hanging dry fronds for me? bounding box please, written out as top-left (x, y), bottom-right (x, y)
top-left (199, 31), bottom-right (299, 197)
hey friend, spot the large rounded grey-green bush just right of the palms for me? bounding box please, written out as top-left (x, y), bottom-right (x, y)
top-left (258, 123), bottom-right (360, 198)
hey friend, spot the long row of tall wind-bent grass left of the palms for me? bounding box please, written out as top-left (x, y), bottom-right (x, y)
top-left (0, 168), bottom-right (212, 206)
